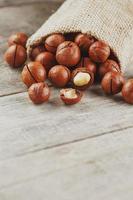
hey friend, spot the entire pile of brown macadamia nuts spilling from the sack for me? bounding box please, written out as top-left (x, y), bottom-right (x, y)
top-left (5, 33), bottom-right (133, 105)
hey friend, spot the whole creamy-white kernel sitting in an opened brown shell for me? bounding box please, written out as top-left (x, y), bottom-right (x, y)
top-left (73, 72), bottom-right (91, 86)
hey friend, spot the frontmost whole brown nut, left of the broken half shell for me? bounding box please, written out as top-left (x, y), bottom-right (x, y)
top-left (28, 83), bottom-right (50, 104)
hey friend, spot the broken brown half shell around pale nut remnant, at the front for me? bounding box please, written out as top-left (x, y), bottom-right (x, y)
top-left (60, 88), bottom-right (83, 105)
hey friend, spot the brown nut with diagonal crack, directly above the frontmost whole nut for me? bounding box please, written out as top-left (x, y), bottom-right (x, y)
top-left (22, 62), bottom-right (46, 87)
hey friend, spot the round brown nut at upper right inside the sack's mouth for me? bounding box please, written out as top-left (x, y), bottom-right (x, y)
top-left (89, 41), bottom-right (110, 63)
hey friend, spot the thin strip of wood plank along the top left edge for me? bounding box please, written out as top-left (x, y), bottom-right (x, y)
top-left (0, 0), bottom-right (64, 7)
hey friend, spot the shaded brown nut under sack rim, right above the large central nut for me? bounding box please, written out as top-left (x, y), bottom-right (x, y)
top-left (75, 33), bottom-right (95, 53)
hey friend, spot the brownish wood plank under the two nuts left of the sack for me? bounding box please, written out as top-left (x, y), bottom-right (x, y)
top-left (0, 1), bottom-right (60, 96)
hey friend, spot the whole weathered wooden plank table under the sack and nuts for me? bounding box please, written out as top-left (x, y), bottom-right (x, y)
top-left (0, 0), bottom-right (133, 200)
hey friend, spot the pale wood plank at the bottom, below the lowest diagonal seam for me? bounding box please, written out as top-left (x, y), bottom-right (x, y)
top-left (0, 129), bottom-right (133, 200)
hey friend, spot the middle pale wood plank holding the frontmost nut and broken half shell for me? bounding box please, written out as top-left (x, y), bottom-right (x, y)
top-left (0, 86), bottom-right (133, 159)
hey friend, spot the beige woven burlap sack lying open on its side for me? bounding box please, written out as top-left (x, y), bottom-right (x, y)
top-left (27, 0), bottom-right (133, 71)
